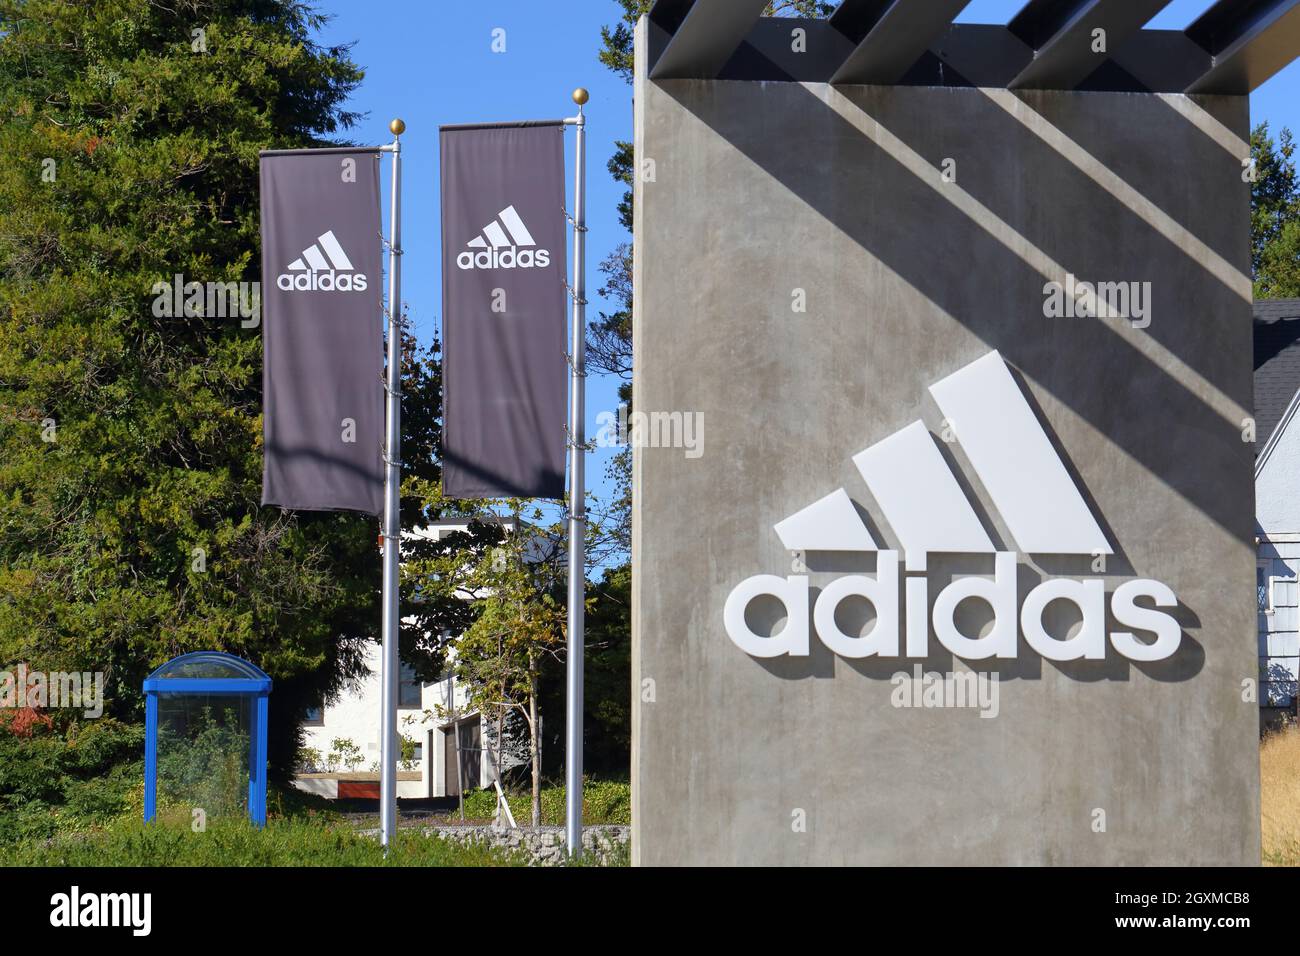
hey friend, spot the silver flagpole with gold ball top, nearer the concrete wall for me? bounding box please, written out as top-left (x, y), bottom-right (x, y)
top-left (564, 87), bottom-right (588, 857)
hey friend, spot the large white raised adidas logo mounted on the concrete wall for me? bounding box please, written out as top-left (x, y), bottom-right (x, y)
top-left (723, 351), bottom-right (1183, 661)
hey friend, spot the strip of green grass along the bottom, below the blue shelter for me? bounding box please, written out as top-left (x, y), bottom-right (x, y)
top-left (0, 816), bottom-right (528, 866)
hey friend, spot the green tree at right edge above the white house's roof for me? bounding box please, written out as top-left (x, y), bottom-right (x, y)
top-left (1251, 122), bottom-right (1300, 299)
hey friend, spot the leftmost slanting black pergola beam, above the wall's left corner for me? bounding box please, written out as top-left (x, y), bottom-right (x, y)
top-left (650, 0), bottom-right (767, 79)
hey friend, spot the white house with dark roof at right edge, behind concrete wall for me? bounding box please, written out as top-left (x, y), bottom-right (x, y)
top-left (1255, 299), bottom-right (1300, 724)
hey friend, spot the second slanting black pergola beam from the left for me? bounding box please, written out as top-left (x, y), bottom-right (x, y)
top-left (831, 0), bottom-right (970, 85)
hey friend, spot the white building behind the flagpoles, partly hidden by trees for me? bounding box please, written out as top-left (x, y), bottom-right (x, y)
top-left (295, 518), bottom-right (527, 799)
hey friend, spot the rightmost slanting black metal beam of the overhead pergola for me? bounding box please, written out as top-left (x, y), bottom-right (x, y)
top-left (1187, 0), bottom-right (1300, 95)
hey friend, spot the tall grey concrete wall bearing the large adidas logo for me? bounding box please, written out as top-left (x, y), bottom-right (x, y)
top-left (632, 18), bottom-right (1260, 865)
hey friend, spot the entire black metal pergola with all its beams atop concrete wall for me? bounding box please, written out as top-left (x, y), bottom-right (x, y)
top-left (645, 0), bottom-right (1300, 95)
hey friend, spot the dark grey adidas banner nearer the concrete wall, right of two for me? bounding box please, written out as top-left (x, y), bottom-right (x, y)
top-left (441, 126), bottom-right (568, 498)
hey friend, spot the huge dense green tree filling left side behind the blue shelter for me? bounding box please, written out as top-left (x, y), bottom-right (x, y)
top-left (0, 0), bottom-right (380, 769)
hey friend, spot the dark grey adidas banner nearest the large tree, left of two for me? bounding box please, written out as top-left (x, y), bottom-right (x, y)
top-left (261, 150), bottom-right (384, 514)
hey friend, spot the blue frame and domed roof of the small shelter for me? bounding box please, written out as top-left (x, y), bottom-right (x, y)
top-left (144, 650), bottom-right (270, 826)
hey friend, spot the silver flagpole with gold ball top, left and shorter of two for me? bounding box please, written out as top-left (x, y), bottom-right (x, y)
top-left (380, 120), bottom-right (406, 849)
